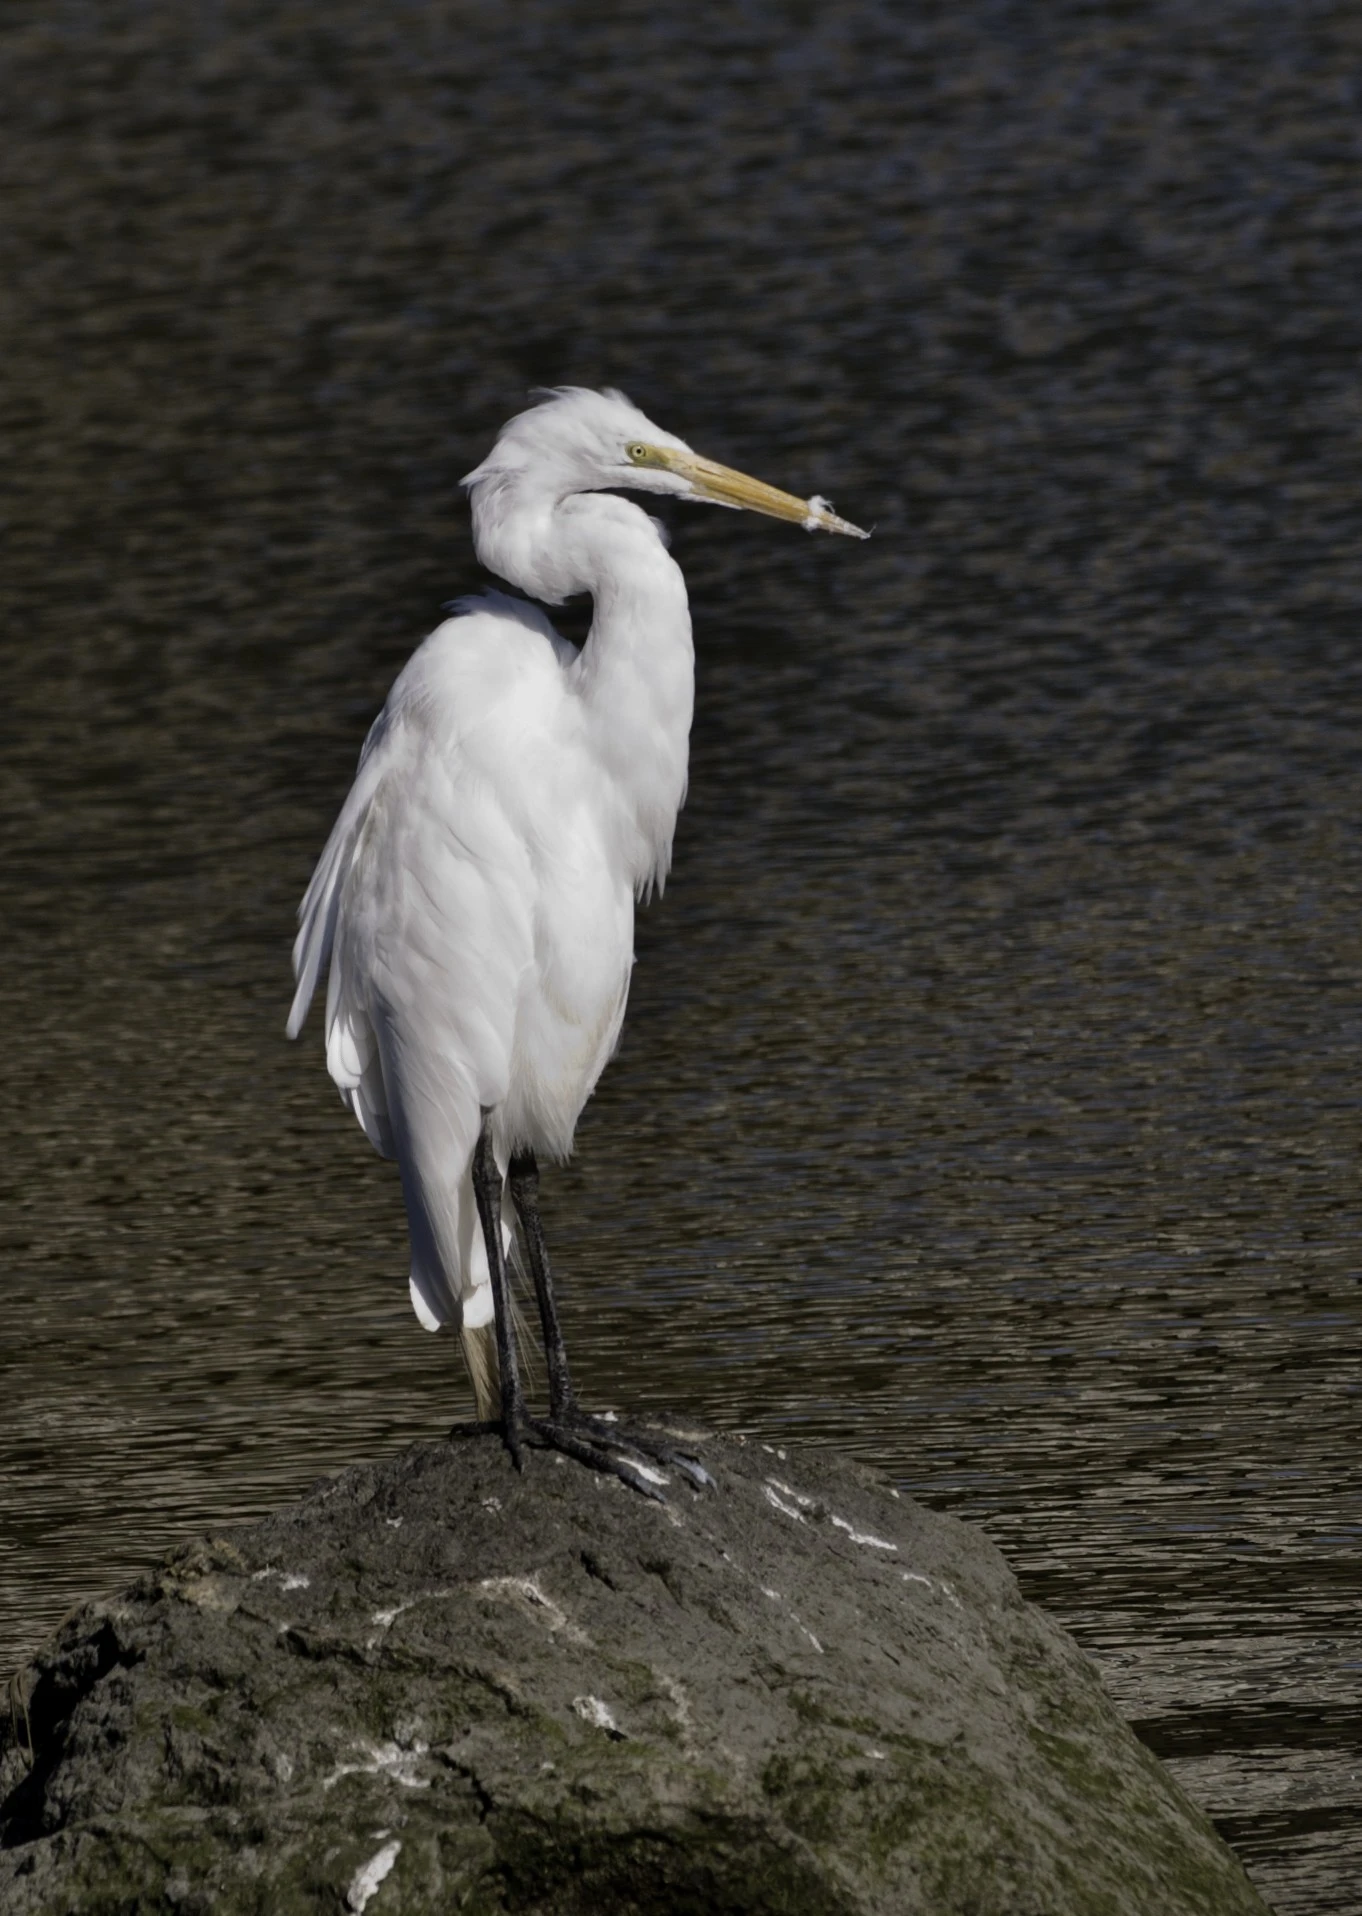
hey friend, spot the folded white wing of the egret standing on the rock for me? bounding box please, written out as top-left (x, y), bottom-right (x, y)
top-left (287, 594), bottom-right (573, 1157)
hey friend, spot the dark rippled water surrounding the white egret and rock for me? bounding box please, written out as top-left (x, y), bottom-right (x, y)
top-left (0, 0), bottom-right (1362, 1916)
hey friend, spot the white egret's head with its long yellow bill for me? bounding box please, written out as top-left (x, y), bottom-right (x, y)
top-left (464, 385), bottom-right (870, 538)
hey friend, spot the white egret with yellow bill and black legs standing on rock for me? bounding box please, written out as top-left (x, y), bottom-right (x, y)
top-left (287, 387), bottom-right (866, 1493)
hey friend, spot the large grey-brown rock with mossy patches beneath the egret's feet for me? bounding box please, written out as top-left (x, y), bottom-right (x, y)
top-left (0, 1437), bottom-right (1264, 1916)
